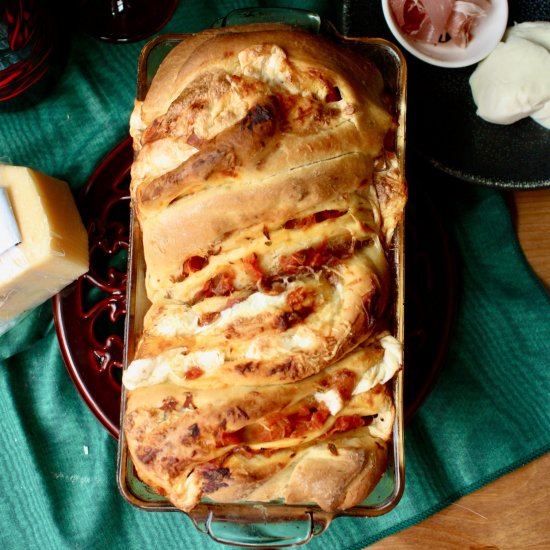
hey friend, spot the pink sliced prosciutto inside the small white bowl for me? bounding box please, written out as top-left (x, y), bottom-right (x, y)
top-left (390, 0), bottom-right (490, 48)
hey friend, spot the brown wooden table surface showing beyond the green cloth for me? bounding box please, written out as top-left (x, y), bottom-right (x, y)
top-left (369, 189), bottom-right (550, 550)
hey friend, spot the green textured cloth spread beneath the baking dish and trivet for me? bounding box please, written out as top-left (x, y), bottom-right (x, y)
top-left (0, 1), bottom-right (550, 550)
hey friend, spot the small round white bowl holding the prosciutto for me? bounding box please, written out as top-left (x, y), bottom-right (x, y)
top-left (382, 0), bottom-right (508, 68)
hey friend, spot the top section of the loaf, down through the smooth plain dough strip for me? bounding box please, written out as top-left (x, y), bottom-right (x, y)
top-left (132, 25), bottom-right (391, 294)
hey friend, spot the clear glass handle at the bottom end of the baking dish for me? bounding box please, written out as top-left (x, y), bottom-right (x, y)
top-left (191, 506), bottom-right (332, 548)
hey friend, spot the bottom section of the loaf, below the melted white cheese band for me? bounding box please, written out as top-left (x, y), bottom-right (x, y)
top-left (125, 344), bottom-right (395, 509)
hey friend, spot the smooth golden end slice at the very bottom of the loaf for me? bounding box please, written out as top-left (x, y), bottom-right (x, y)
top-left (196, 428), bottom-right (387, 512)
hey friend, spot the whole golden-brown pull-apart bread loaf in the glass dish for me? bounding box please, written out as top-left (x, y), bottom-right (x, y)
top-left (123, 20), bottom-right (406, 511)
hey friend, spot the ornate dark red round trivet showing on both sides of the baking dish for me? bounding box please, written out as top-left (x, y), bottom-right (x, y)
top-left (53, 138), bottom-right (456, 437)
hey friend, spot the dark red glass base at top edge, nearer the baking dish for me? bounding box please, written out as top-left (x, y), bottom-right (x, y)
top-left (79, 0), bottom-right (179, 42)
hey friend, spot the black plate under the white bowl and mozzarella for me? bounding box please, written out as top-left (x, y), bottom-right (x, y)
top-left (339, 0), bottom-right (550, 189)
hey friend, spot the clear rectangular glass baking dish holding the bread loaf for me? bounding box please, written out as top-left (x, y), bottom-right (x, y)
top-left (117, 8), bottom-right (406, 548)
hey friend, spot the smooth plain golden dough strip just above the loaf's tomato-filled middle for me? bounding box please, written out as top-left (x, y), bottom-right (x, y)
top-left (141, 153), bottom-right (376, 295)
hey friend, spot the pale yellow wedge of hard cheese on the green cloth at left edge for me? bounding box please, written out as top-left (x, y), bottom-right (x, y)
top-left (0, 165), bottom-right (88, 319)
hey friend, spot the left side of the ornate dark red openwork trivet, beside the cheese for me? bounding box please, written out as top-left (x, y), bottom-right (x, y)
top-left (53, 138), bottom-right (133, 437)
